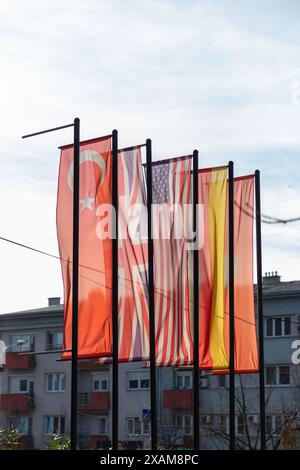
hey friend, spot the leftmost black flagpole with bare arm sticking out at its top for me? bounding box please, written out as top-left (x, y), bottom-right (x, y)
top-left (22, 118), bottom-right (80, 450)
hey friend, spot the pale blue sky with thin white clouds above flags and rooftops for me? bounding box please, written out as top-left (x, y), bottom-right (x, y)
top-left (0, 0), bottom-right (300, 313)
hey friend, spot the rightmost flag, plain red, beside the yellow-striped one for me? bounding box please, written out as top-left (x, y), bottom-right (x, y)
top-left (224, 175), bottom-right (259, 373)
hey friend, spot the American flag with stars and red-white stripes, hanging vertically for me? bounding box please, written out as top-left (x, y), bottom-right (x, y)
top-left (152, 156), bottom-right (193, 366)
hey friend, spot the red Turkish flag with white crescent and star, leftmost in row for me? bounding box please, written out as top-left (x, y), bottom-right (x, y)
top-left (56, 136), bottom-right (112, 359)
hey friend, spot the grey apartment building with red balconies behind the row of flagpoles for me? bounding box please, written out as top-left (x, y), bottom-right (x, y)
top-left (0, 273), bottom-right (300, 449)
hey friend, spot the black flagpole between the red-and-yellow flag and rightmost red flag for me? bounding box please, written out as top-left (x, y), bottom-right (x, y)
top-left (228, 162), bottom-right (235, 450)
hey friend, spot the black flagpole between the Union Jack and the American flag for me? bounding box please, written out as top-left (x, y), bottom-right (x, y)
top-left (146, 139), bottom-right (157, 451)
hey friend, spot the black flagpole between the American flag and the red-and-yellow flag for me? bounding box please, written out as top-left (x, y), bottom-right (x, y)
top-left (193, 150), bottom-right (200, 451)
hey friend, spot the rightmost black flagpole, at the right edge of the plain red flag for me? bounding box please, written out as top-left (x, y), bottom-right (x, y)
top-left (255, 170), bottom-right (266, 450)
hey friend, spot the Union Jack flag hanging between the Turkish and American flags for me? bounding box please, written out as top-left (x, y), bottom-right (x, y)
top-left (118, 147), bottom-right (149, 362)
